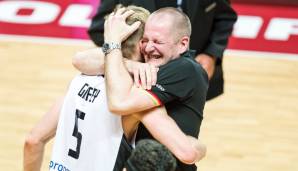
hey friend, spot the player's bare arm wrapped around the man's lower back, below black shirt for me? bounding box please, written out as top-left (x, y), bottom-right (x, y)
top-left (134, 106), bottom-right (206, 164)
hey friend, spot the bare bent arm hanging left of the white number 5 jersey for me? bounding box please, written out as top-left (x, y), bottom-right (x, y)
top-left (23, 98), bottom-right (63, 171)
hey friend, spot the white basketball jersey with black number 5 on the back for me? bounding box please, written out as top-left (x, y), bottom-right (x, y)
top-left (49, 75), bottom-right (123, 171)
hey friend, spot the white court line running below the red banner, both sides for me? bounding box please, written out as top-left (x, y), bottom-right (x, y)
top-left (0, 34), bottom-right (298, 61)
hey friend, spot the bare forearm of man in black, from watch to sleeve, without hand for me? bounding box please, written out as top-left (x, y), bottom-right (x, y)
top-left (105, 49), bottom-right (160, 115)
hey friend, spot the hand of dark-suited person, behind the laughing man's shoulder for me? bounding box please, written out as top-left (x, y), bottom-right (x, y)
top-left (195, 53), bottom-right (216, 80)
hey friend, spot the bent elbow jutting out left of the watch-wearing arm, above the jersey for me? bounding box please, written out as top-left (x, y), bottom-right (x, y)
top-left (72, 48), bottom-right (104, 75)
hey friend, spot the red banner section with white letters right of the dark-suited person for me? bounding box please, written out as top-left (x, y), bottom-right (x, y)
top-left (229, 4), bottom-right (298, 54)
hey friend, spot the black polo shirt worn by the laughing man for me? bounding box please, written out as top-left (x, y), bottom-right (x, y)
top-left (137, 51), bottom-right (208, 171)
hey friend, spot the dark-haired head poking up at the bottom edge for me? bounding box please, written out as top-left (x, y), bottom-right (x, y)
top-left (125, 139), bottom-right (176, 171)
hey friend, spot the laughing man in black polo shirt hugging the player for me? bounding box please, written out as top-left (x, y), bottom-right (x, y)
top-left (104, 8), bottom-right (208, 171)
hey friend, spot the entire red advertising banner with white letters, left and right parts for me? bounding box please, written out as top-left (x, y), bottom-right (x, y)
top-left (0, 0), bottom-right (298, 54)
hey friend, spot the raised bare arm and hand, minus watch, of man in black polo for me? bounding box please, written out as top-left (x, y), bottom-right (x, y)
top-left (104, 9), bottom-right (160, 114)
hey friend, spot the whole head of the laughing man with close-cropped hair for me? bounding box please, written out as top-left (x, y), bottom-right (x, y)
top-left (141, 7), bottom-right (191, 66)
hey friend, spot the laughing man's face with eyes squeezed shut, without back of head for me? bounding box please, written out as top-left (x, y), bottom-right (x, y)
top-left (141, 16), bottom-right (179, 66)
